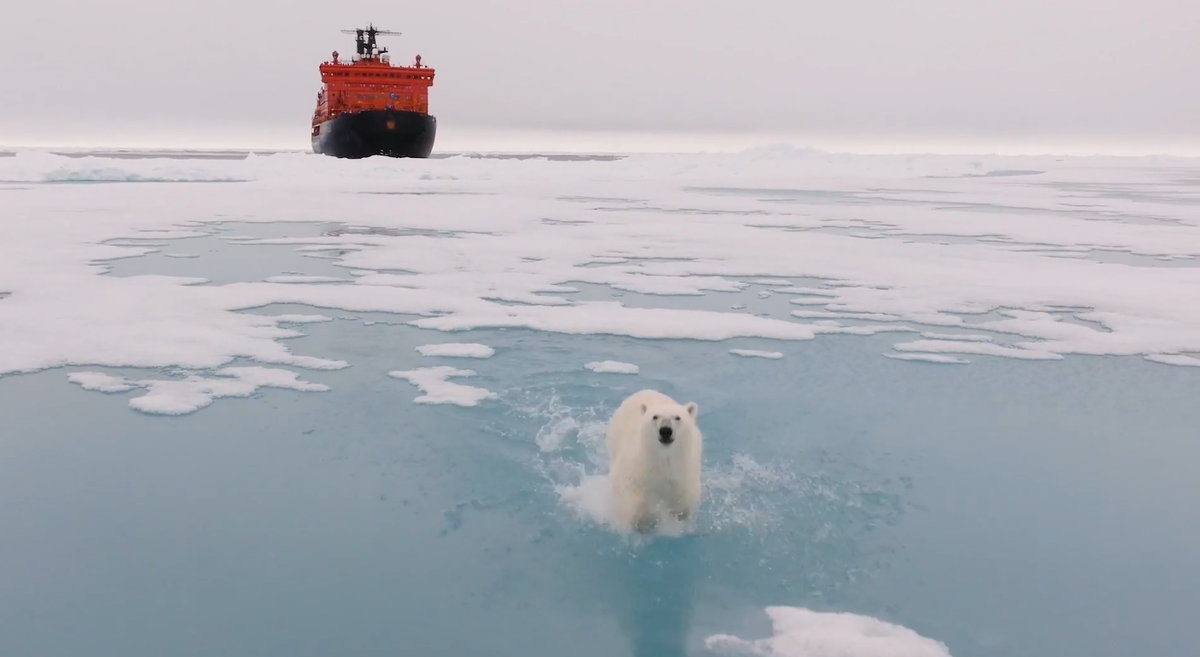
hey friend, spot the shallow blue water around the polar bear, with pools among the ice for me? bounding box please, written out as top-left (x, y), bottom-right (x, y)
top-left (0, 225), bottom-right (1200, 657)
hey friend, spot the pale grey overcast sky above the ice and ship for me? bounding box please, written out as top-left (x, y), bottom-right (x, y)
top-left (0, 0), bottom-right (1200, 151)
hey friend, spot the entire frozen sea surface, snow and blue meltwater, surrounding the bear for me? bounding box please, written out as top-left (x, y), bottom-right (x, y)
top-left (0, 147), bottom-right (1200, 657)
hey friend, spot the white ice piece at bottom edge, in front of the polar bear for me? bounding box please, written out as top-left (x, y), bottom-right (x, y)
top-left (704, 607), bottom-right (950, 657)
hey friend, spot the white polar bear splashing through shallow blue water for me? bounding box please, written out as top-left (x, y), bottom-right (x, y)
top-left (605, 390), bottom-right (703, 534)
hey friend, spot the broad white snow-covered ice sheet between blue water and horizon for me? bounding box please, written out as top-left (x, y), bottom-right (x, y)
top-left (0, 149), bottom-right (1200, 400)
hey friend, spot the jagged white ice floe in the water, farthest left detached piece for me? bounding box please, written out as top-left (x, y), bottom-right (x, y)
top-left (67, 367), bottom-right (330, 415)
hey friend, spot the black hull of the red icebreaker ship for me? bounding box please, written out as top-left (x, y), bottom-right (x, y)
top-left (312, 109), bottom-right (438, 158)
